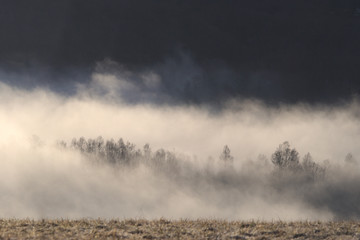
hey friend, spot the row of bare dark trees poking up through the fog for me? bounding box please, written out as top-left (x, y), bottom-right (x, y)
top-left (59, 137), bottom-right (356, 180)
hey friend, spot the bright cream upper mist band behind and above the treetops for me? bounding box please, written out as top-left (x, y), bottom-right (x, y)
top-left (0, 78), bottom-right (360, 160)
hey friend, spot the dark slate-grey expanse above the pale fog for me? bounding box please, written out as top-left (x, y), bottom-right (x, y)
top-left (0, 0), bottom-right (360, 103)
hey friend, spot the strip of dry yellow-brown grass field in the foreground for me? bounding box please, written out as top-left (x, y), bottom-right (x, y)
top-left (0, 219), bottom-right (360, 239)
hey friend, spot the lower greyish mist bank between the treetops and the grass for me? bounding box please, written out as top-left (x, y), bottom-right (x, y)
top-left (0, 133), bottom-right (360, 220)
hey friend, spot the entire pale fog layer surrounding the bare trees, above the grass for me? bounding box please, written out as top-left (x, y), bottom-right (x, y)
top-left (0, 77), bottom-right (360, 220)
